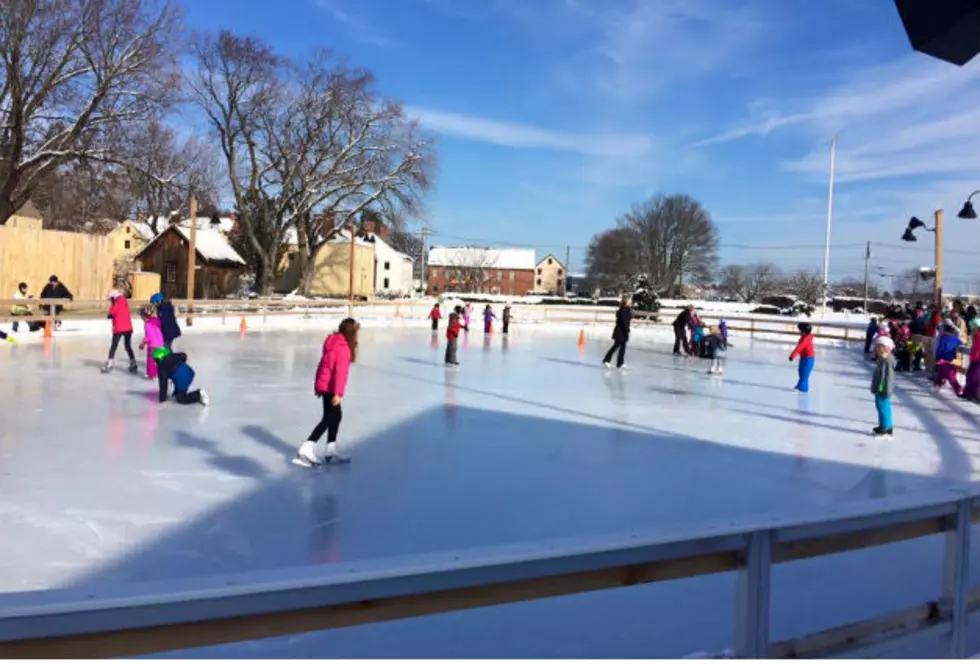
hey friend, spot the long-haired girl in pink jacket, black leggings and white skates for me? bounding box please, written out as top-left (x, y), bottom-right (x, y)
top-left (293, 318), bottom-right (361, 468)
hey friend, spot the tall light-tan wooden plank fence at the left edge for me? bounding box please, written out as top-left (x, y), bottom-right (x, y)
top-left (0, 226), bottom-right (113, 300)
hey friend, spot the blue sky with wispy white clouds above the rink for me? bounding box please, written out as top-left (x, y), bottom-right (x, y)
top-left (186, 0), bottom-right (980, 290)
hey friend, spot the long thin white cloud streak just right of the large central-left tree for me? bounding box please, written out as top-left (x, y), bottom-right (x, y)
top-left (405, 106), bottom-right (654, 157)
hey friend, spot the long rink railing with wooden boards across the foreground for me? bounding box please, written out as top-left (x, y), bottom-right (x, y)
top-left (0, 489), bottom-right (980, 658)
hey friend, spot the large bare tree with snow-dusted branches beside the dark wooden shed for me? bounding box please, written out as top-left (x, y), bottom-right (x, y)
top-left (192, 32), bottom-right (432, 293)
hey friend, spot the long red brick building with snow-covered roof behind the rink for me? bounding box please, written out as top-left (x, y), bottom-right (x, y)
top-left (426, 247), bottom-right (536, 295)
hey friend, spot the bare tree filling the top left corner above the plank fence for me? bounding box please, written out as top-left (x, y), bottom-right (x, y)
top-left (0, 0), bottom-right (176, 224)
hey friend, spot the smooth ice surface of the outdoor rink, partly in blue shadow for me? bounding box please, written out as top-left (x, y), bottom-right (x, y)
top-left (0, 323), bottom-right (980, 657)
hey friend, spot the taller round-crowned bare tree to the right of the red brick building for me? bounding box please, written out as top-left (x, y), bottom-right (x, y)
top-left (619, 194), bottom-right (718, 292)
